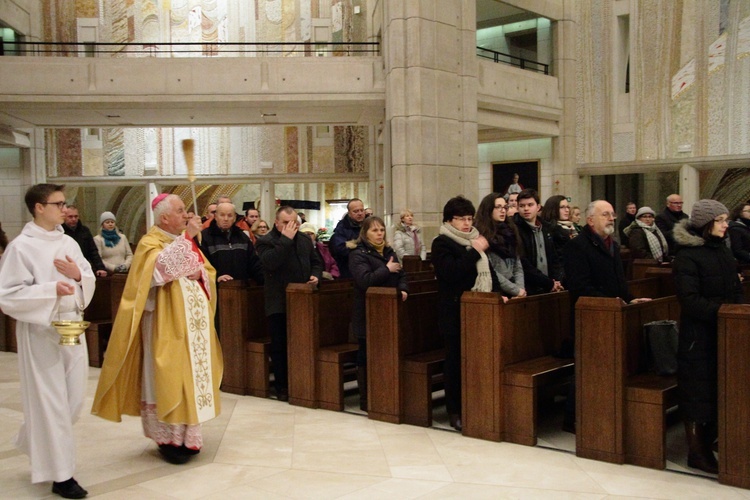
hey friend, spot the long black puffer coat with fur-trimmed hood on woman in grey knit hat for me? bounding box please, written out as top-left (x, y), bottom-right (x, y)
top-left (672, 220), bottom-right (744, 422)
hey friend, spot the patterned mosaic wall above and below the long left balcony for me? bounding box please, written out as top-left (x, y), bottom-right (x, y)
top-left (44, 0), bottom-right (369, 178)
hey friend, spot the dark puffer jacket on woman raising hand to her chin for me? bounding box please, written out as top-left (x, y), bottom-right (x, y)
top-left (349, 242), bottom-right (409, 338)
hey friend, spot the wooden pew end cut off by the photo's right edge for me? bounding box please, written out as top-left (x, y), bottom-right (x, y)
top-left (718, 304), bottom-right (750, 488)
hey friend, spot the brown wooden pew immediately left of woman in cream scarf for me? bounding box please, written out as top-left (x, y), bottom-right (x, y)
top-left (367, 279), bottom-right (445, 427)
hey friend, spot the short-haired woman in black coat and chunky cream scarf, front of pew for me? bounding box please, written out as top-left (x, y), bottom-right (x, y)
top-left (432, 196), bottom-right (499, 431)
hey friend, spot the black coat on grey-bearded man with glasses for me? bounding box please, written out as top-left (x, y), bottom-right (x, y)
top-left (563, 226), bottom-right (633, 306)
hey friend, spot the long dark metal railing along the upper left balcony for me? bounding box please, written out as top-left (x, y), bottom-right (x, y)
top-left (4, 41), bottom-right (380, 57)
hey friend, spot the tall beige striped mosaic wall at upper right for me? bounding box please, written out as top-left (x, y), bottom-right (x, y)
top-left (576, 0), bottom-right (750, 206)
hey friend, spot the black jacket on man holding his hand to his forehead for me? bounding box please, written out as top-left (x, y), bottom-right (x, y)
top-left (255, 226), bottom-right (323, 316)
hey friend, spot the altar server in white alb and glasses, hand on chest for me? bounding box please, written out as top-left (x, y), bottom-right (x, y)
top-left (0, 184), bottom-right (96, 498)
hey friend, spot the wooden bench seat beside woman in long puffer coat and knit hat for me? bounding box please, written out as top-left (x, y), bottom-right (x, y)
top-left (625, 373), bottom-right (677, 469)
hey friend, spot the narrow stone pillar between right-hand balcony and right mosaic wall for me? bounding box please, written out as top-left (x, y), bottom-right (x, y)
top-left (542, 0), bottom-right (580, 207)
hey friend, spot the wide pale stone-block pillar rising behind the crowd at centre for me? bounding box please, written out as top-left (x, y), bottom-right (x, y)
top-left (383, 0), bottom-right (478, 247)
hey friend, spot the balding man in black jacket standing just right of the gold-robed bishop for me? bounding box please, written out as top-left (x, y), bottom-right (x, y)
top-left (200, 203), bottom-right (263, 285)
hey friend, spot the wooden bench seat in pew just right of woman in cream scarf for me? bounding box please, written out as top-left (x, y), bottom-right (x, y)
top-left (503, 356), bottom-right (574, 446)
